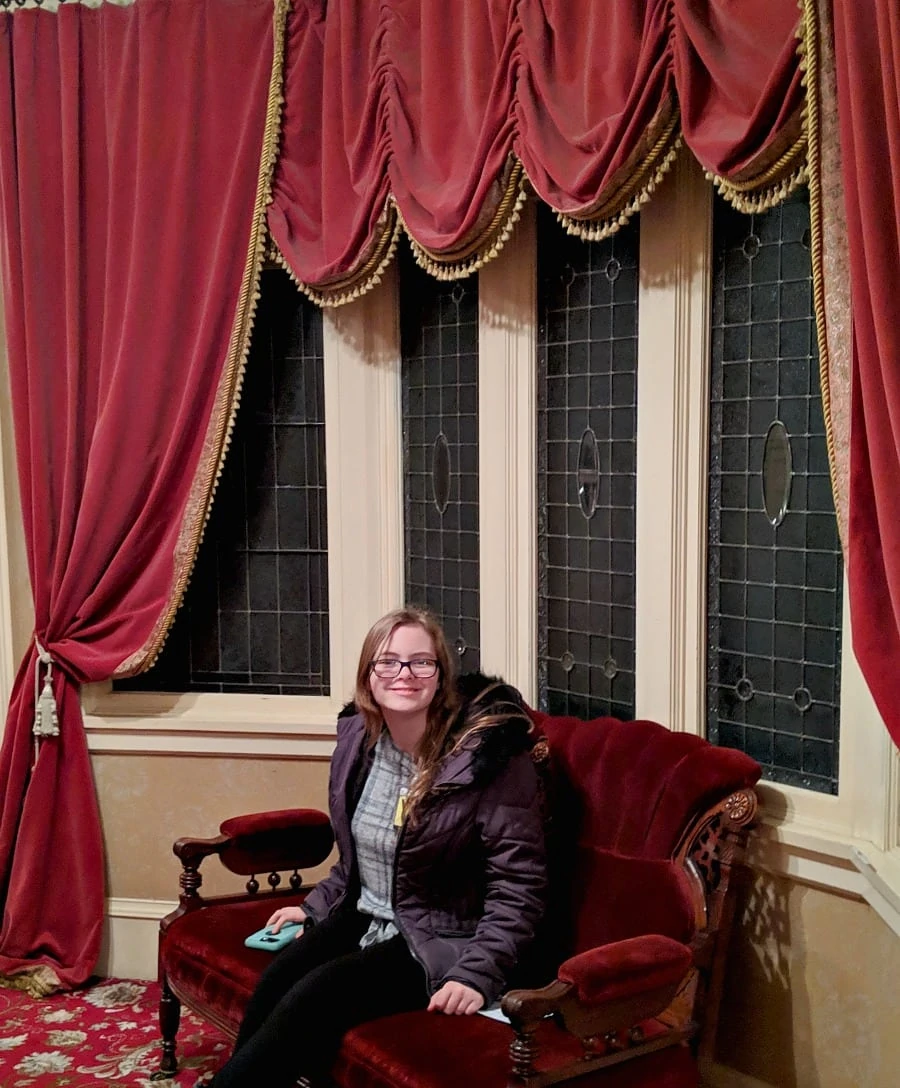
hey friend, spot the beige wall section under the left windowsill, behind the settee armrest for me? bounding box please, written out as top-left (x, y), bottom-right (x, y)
top-left (94, 755), bottom-right (329, 901)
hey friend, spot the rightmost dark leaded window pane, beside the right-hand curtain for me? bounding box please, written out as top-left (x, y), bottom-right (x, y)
top-left (707, 194), bottom-right (842, 793)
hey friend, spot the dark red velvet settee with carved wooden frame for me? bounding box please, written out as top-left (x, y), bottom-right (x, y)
top-left (159, 713), bottom-right (760, 1088)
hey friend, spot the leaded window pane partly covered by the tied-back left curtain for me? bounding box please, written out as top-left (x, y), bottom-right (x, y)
top-left (116, 270), bottom-right (330, 695)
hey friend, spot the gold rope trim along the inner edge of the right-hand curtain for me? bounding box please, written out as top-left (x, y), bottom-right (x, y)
top-left (798, 0), bottom-right (840, 511)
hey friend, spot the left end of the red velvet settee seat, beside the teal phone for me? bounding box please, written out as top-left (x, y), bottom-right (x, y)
top-left (160, 897), bottom-right (303, 1034)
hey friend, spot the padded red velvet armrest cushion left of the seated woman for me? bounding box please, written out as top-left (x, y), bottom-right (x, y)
top-left (218, 808), bottom-right (334, 876)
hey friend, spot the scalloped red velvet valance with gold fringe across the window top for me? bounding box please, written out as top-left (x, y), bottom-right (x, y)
top-left (269, 0), bottom-right (804, 302)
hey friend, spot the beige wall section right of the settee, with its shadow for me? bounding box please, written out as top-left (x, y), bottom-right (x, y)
top-left (711, 873), bottom-right (900, 1088)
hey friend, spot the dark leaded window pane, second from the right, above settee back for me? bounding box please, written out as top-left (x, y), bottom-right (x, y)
top-left (538, 210), bottom-right (638, 718)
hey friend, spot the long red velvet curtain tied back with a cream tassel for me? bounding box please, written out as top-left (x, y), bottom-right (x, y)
top-left (0, 0), bottom-right (278, 988)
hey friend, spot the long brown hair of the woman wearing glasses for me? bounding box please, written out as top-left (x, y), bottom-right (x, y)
top-left (355, 605), bottom-right (459, 757)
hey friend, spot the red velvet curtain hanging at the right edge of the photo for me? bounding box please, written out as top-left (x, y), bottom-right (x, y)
top-left (834, 0), bottom-right (900, 744)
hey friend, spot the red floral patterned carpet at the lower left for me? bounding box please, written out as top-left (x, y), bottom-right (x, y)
top-left (0, 978), bottom-right (231, 1088)
